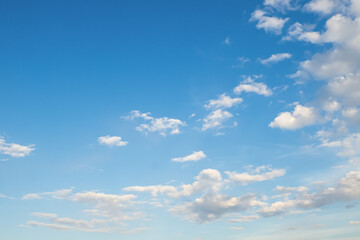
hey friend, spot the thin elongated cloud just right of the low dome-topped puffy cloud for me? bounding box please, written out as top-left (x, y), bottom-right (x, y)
top-left (225, 166), bottom-right (285, 185)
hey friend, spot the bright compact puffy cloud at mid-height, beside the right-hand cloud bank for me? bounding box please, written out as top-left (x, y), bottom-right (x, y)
top-left (269, 104), bottom-right (320, 130)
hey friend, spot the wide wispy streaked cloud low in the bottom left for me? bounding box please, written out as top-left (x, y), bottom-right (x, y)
top-left (23, 189), bottom-right (144, 233)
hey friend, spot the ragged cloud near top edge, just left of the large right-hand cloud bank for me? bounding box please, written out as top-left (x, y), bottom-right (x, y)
top-left (250, 10), bottom-right (289, 34)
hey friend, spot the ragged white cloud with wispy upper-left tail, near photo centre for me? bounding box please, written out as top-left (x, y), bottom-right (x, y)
top-left (125, 110), bottom-right (185, 136)
